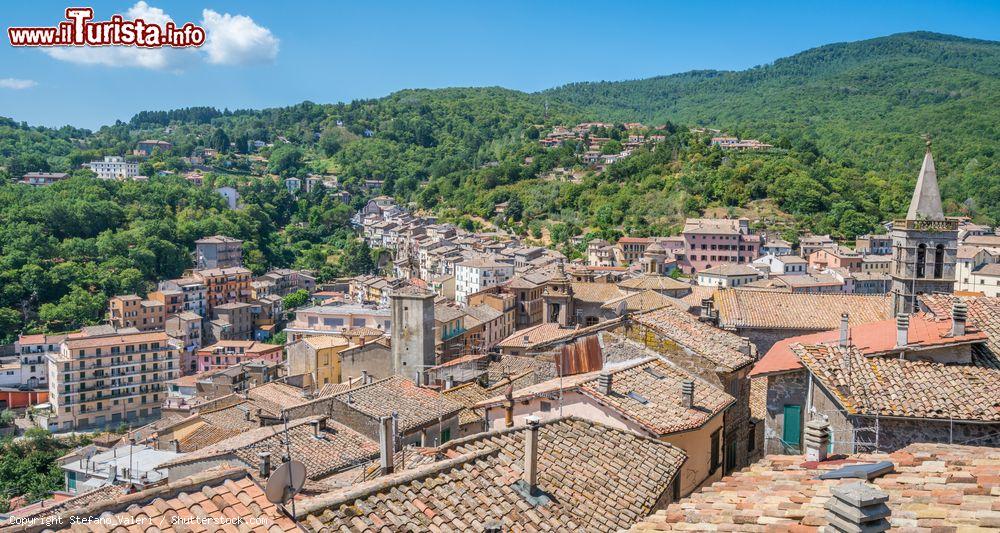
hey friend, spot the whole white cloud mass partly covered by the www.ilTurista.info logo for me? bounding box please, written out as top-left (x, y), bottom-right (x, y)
top-left (42, 0), bottom-right (278, 71)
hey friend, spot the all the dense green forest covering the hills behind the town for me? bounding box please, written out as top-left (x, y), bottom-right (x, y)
top-left (0, 33), bottom-right (1000, 340)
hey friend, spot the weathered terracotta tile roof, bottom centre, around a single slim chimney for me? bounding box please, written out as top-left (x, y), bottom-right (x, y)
top-left (298, 418), bottom-right (685, 531)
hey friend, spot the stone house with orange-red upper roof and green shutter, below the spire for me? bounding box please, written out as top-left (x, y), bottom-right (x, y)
top-left (751, 295), bottom-right (1000, 453)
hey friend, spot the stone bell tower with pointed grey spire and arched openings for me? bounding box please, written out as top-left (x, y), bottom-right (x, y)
top-left (890, 141), bottom-right (958, 315)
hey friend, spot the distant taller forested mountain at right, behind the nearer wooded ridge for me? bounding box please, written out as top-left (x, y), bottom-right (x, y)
top-left (540, 32), bottom-right (1000, 214)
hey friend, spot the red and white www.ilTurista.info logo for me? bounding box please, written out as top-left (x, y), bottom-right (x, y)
top-left (7, 7), bottom-right (205, 48)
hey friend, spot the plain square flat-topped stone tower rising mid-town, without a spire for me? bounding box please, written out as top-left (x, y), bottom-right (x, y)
top-left (389, 286), bottom-right (437, 385)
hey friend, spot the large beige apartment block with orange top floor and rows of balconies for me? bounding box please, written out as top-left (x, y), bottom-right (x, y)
top-left (46, 326), bottom-right (180, 430)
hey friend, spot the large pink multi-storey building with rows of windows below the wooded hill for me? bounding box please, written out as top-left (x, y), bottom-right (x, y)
top-left (680, 218), bottom-right (761, 274)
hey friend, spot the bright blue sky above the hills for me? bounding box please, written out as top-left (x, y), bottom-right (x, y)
top-left (0, 0), bottom-right (1000, 128)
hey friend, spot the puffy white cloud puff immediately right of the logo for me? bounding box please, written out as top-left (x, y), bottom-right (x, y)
top-left (201, 9), bottom-right (279, 65)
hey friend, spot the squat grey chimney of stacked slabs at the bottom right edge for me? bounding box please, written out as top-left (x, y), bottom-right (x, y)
top-left (826, 482), bottom-right (892, 533)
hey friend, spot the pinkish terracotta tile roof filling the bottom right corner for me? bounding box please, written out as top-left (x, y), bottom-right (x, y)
top-left (632, 444), bottom-right (1000, 532)
